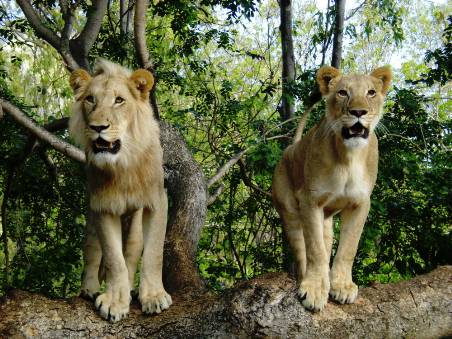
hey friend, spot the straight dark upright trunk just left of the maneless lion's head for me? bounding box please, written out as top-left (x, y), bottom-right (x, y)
top-left (279, 0), bottom-right (295, 121)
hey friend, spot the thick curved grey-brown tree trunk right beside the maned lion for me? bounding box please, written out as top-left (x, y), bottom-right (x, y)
top-left (160, 122), bottom-right (207, 292)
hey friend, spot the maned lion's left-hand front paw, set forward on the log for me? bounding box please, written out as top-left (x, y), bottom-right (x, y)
top-left (94, 288), bottom-right (131, 322)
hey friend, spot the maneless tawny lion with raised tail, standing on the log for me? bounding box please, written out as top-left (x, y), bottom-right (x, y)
top-left (272, 66), bottom-right (392, 311)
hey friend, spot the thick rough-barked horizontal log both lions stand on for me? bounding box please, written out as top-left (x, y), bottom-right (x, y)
top-left (0, 266), bottom-right (452, 338)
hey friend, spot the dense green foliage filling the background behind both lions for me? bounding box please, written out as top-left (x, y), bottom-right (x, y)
top-left (0, 0), bottom-right (452, 296)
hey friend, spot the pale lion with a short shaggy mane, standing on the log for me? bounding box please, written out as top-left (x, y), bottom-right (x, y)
top-left (69, 60), bottom-right (172, 321)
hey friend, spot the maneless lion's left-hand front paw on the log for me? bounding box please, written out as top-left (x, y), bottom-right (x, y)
top-left (298, 274), bottom-right (330, 312)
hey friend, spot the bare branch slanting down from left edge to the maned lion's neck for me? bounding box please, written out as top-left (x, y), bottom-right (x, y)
top-left (0, 100), bottom-right (86, 163)
